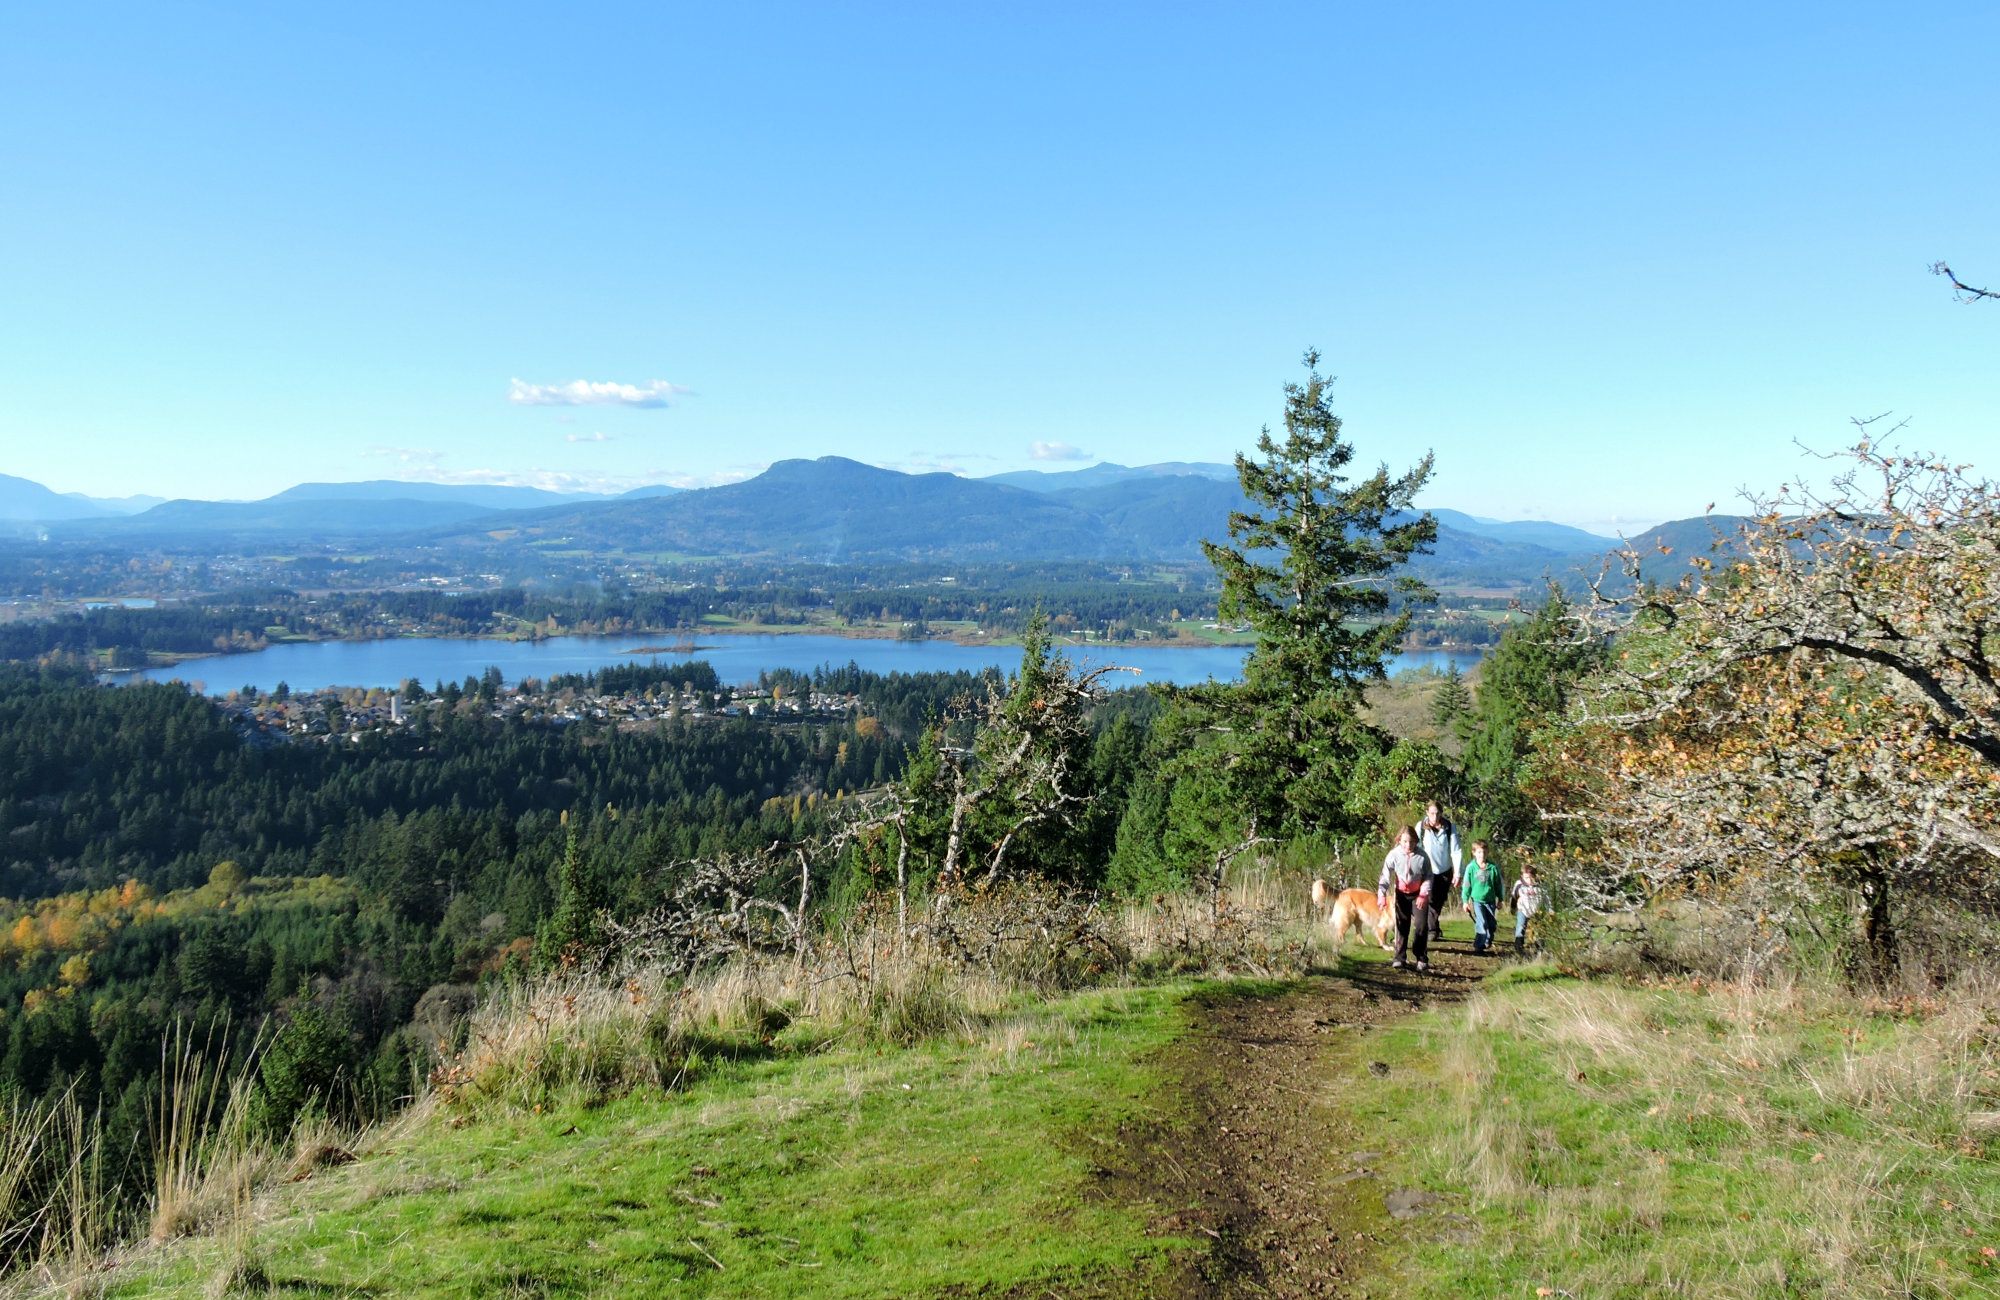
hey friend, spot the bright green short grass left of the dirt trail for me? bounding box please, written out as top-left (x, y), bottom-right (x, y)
top-left (108, 986), bottom-right (1188, 1296)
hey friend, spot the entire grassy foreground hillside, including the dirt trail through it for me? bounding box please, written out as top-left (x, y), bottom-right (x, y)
top-left (14, 888), bottom-right (2000, 1300)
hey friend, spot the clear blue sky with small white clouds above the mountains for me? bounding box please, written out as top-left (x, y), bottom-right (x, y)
top-left (0, 4), bottom-right (2000, 528)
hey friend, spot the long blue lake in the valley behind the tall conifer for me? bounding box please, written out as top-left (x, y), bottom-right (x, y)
top-left (116, 632), bottom-right (1480, 694)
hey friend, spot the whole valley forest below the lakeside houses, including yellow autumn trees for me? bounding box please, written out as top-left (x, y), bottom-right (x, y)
top-left (0, 664), bottom-right (1088, 1224)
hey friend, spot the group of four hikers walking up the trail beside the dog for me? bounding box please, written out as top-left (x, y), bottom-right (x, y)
top-left (1376, 800), bottom-right (1542, 970)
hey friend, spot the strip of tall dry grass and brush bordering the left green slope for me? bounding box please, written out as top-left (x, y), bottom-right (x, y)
top-left (430, 870), bottom-right (1312, 1110)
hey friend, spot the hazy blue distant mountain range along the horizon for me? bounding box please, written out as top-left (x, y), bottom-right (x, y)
top-left (0, 456), bottom-right (1734, 586)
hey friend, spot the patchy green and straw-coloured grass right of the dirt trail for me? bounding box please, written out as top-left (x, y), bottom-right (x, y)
top-left (1354, 966), bottom-right (2000, 1300)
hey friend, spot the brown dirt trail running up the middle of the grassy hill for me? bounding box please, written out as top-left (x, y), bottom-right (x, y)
top-left (1086, 940), bottom-right (1498, 1300)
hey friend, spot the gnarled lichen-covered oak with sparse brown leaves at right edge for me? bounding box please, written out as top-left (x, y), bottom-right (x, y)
top-left (1544, 438), bottom-right (2000, 970)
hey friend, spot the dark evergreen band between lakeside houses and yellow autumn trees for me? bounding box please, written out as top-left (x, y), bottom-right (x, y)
top-left (0, 668), bottom-right (936, 900)
